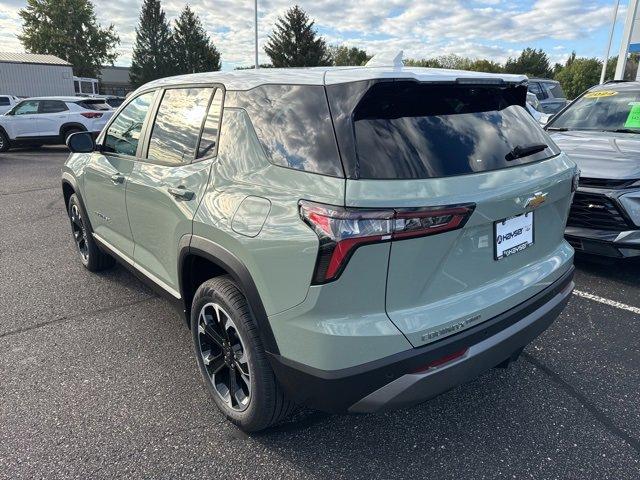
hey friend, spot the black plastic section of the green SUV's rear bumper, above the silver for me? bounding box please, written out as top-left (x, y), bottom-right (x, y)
top-left (269, 266), bottom-right (574, 412)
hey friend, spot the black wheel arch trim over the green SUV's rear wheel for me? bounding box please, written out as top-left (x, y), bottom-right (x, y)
top-left (178, 235), bottom-right (280, 355)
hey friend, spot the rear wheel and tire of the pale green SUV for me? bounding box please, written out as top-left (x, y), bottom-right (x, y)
top-left (191, 276), bottom-right (295, 432)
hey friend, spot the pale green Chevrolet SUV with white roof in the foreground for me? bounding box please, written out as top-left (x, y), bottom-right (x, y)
top-left (62, 67), bottom-right (577, 431)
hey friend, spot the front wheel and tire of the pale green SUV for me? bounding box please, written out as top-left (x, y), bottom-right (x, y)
top-left (67, 193), bottom-right (115, 272)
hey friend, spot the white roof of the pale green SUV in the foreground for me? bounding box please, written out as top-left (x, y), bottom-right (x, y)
top-left (141, 66), bottom-right (527, 90)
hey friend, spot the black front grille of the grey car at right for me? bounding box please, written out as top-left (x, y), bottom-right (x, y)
top-left (567, 192), bottom-right (630, 231)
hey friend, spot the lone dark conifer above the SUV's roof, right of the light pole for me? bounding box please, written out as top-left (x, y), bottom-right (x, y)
top-left (264, 5), bottom-right (331, 67)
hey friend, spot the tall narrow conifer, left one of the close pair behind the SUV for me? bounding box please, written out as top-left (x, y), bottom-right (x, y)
top-left (129, 0), bottom-right (174, 87)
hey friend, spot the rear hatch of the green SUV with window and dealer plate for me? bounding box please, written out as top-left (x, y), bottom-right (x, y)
top-left (327, 80), bottom-right (575, 346)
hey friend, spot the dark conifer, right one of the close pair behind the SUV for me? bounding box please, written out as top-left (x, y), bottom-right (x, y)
top-left (171, 5), bottom-right (220, 74)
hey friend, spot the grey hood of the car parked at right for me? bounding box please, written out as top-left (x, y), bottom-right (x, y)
top-left (549, 131), bottom-right (640, 180)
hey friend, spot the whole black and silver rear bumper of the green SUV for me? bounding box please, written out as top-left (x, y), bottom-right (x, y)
top-left (269, 266), bottom-right (574, 413)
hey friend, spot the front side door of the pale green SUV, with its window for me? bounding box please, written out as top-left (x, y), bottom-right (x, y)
top-left (84, 92), bottom-right (156, 262)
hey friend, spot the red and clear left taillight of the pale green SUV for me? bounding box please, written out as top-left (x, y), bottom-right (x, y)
top-left (299, 200), bottom-right (474, 284)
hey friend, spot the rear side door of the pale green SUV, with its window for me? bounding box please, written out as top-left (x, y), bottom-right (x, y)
top-left (127, 86), bottom-right (224, 297)
